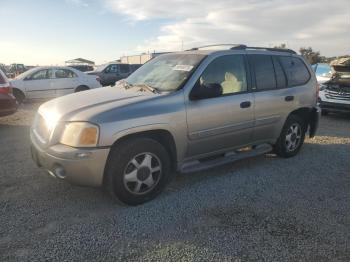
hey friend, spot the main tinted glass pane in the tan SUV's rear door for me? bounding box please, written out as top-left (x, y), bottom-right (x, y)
top-left (250, 55), bottom-right (276, 90)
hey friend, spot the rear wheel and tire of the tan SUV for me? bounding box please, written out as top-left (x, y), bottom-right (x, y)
top-left (274, 115), bottom-right (307, 158)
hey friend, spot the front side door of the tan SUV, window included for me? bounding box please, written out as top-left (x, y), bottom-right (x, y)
top-left (186, 55), bottom-right (254, 158)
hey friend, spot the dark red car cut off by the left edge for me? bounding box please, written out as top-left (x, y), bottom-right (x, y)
top-left (0, 70), bottom-right (17, 116)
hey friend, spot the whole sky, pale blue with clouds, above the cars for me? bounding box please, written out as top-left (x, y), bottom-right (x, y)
top-left (0, 0), bottom-right (350, 65)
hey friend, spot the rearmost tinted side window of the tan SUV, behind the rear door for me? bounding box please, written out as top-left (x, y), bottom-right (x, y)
top-left (280, 56), bottom-right (311, 86)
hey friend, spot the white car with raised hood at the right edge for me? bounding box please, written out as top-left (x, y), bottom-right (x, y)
top-left (319, 57), bottom-right (350, 115)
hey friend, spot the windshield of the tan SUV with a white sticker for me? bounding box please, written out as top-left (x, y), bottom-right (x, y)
top-left (126, 54), bottom-right (205, 91)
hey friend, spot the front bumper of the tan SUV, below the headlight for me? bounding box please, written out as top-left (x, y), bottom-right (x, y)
top-left (31, 132), bottom-right (109, 187)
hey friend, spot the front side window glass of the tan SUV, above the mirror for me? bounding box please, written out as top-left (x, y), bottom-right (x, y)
top-left (199, 55), bottom-right (247, 95)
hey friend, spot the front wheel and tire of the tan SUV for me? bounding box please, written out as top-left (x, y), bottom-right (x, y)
top-left (105, 138), bottom-right (171, 206)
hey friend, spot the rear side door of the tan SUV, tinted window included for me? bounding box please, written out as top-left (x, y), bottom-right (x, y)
top-left (249, 54), bottom-right (306, 142)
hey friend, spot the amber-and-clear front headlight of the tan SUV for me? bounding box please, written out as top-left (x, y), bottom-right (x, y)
top-left (60, 122), bottom-right (99, 147)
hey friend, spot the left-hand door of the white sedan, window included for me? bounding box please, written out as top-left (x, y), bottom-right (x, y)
top-left (23, 68), bottom-right (55, 99)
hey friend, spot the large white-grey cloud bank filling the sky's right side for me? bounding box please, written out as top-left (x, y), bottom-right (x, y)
top-left (105, 0), bottom-right (350, 55)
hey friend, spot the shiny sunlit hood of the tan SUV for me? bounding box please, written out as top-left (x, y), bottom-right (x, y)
top-left (38, 87), bottom-right (157, 122)
